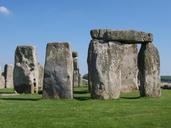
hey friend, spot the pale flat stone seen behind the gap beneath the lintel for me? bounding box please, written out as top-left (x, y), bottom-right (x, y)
top-left (121, 44), bottom-right (138, 92)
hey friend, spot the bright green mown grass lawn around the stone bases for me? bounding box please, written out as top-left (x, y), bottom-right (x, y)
top-left (0, 87), bottom-right (171, 128)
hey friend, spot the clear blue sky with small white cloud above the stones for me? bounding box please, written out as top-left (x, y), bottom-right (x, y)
top-left (0, 0), bottom-right (171, 75)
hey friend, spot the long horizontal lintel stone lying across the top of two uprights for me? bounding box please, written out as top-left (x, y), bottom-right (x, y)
top-left (91, 29), bottom-right (153, 43)
